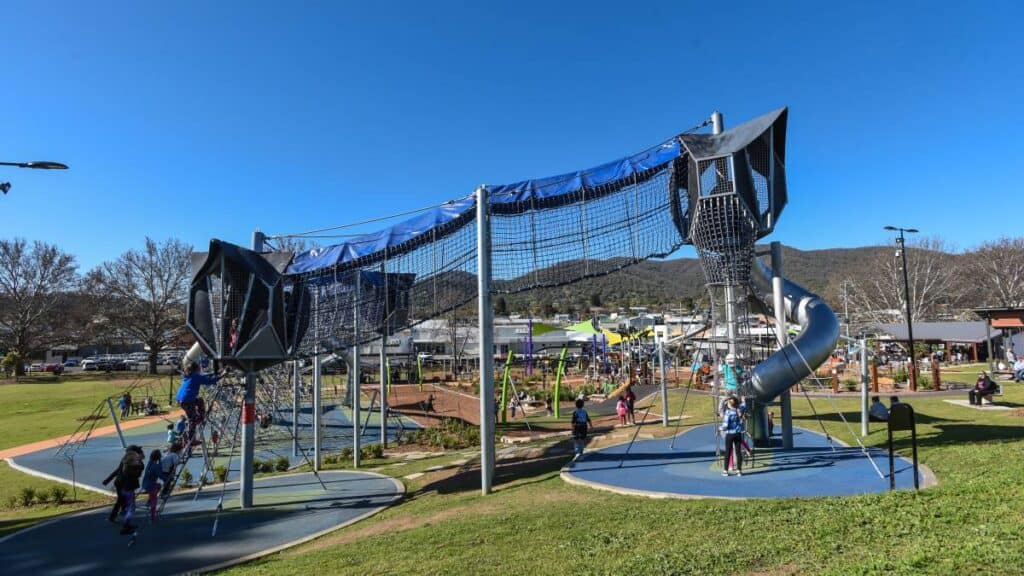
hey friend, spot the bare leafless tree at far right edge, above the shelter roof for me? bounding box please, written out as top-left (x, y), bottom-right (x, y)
top-left (965, 237), bottom-right (1024, 307)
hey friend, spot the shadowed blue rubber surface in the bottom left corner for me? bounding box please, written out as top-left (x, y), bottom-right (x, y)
top-left (0, 471), bottom-right (402, 576)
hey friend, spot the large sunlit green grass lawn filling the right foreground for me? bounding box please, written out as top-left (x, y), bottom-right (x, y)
top-left (220, 385), bottom-right (1024, 576)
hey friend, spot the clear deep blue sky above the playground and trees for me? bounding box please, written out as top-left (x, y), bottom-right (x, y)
top-left (0, 0), bottom-right (1024, 269)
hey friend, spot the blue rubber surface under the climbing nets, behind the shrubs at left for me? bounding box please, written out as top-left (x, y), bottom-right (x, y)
top-left (10, 406), bottom-right (417, 489)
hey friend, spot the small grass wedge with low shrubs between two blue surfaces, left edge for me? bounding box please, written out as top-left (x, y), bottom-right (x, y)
top-left (0, 461), bottom-right (113, 536)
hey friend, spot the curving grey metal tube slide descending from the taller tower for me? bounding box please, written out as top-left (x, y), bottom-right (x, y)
top-left (751, 257), bottom-right (839, 402)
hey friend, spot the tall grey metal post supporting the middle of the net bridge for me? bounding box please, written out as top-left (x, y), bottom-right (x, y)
top-left (476, 186), bottom-right (495, 494)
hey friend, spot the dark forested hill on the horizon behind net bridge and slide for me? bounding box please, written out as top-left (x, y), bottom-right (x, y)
top-left (504, 246), bottom-right (894, 313)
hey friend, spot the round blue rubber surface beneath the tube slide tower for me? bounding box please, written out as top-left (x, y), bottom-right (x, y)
top-left (565, 424), bottom-right (925, 498)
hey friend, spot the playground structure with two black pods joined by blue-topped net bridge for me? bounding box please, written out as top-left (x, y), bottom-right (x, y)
top-left (172, 109), bottom-right (860, 506)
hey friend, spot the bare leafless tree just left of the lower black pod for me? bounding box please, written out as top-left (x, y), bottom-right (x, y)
top-left (87, 238), bottom-right (191, 374)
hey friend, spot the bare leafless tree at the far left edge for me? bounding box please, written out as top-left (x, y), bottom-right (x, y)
top-left (0, 238), bottom-right (79, 375)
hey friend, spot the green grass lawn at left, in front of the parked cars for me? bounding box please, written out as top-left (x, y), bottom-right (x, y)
top-left (0, 375), bottom-right (168, 450)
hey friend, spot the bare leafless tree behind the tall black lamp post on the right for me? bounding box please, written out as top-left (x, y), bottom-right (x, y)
top-left (848, 238), bottom-right (964, 326)
